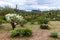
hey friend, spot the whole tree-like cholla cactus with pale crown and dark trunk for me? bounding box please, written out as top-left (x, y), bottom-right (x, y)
top-left (5, 14), bottom-right (23, 30)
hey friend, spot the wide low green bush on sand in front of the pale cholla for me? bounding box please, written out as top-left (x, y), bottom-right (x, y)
top-left (11, 28), bottom-right (32, 37)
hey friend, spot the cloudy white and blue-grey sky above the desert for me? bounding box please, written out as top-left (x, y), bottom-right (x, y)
top-left (0, 0), bottom-right (60, 10)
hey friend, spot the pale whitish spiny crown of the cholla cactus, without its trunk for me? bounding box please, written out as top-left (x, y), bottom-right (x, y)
top-left (5, 14), bottom-right (23, 22)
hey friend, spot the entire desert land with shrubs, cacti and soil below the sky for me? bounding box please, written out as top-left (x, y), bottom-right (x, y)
top-left (0, 6), bottom-right (60, 40)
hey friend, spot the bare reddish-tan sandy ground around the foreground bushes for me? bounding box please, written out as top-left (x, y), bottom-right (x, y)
top-left (0, 21), bottom-right (60, 40)
